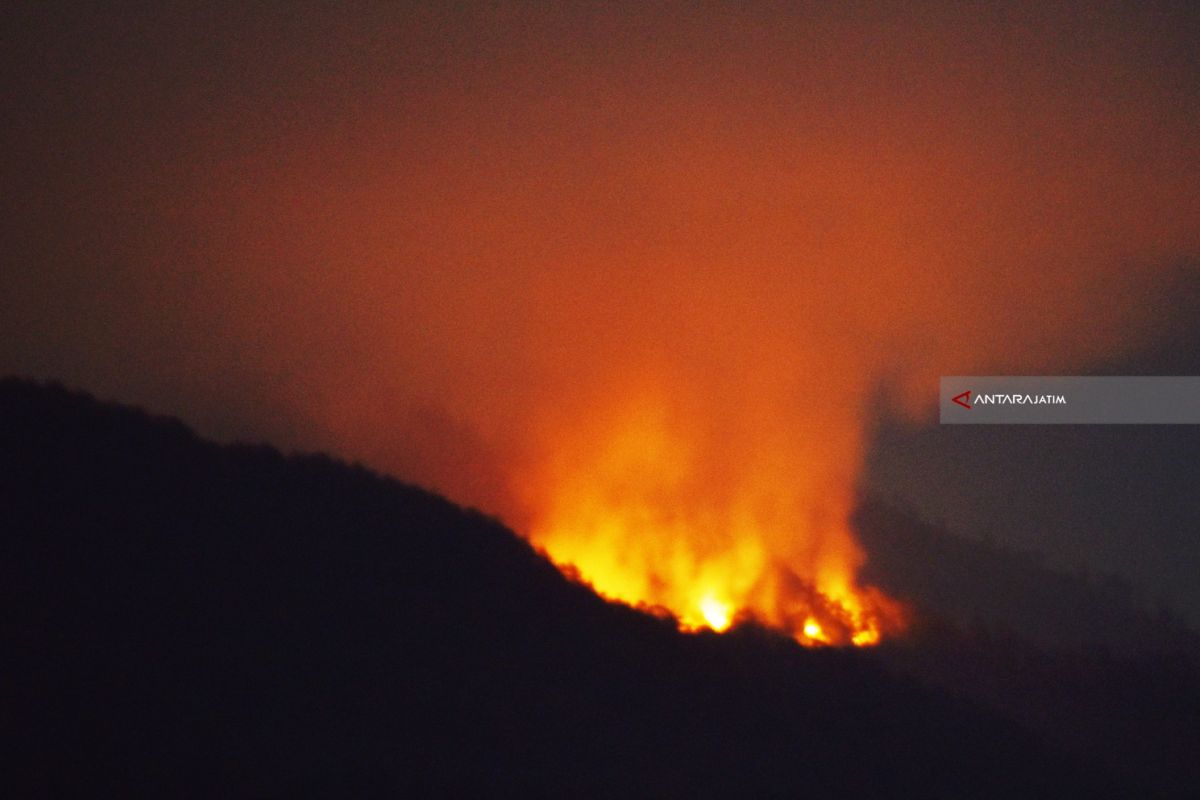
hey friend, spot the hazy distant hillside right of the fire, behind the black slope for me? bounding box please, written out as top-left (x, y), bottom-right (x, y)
top-left (856, 500), bottom-right (1200, 796)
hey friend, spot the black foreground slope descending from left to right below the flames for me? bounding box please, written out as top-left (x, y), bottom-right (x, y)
top-left (0, 380), bottom-right (1120, 796)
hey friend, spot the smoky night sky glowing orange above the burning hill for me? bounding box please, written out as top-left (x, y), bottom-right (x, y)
top-left (0, 1), bottom-right (1200, 622)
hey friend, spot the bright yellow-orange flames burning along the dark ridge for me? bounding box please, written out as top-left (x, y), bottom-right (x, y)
top-left (520, 398), bottom-right (904, 646)
